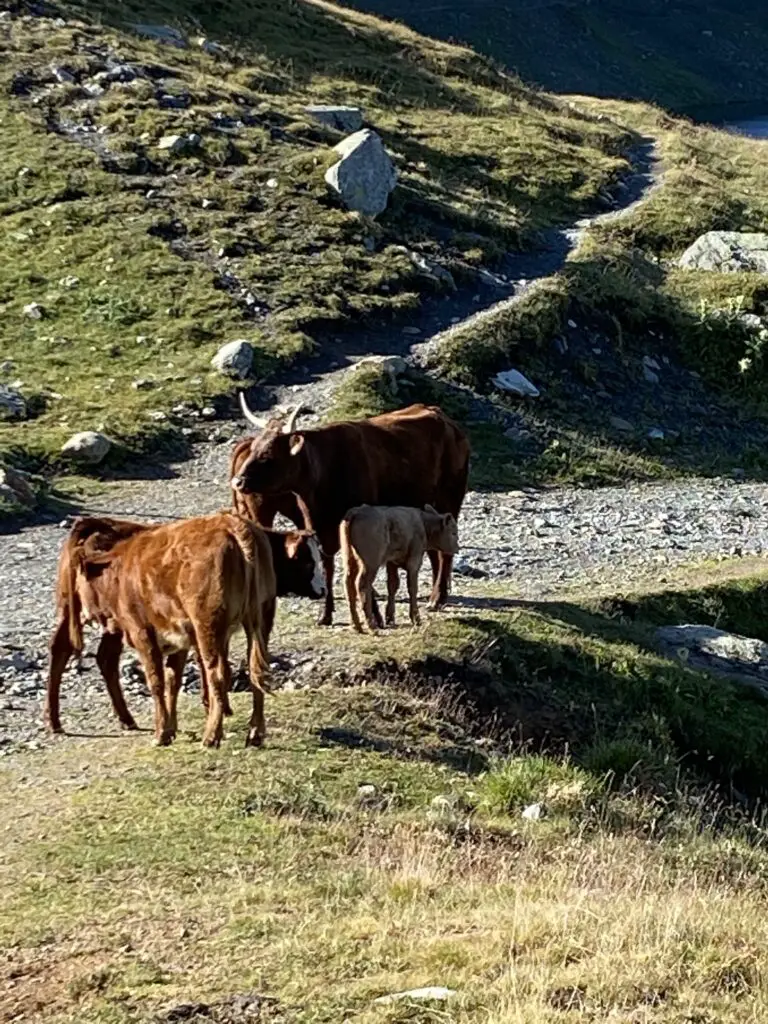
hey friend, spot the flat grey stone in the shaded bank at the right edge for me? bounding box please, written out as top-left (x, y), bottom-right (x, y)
top-left (655, 626), bottom-right (768, 698)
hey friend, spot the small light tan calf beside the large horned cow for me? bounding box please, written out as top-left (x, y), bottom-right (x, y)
top-left (339, 505), bottom-right (459, 633)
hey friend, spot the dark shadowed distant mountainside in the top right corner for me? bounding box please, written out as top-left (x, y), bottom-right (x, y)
top-left (339, 0), bottom-right (768, 116)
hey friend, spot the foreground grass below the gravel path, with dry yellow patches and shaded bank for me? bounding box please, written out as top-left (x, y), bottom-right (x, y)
top-left (0, 569), bottom-right (768, 1024)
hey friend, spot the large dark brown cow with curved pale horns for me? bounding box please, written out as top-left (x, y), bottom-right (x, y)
top-left (230, 394), bottom-right (469, 625)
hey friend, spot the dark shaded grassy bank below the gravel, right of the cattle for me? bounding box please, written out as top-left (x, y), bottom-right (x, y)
top-left (360, 603), bottom-right (768, 801)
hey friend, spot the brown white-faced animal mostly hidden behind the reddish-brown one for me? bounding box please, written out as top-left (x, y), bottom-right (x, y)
top-left (46, 517), bottom-right (325, 732)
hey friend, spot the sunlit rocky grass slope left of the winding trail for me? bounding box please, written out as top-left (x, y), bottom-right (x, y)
top-left (0, 0), bottom-right (631, 466)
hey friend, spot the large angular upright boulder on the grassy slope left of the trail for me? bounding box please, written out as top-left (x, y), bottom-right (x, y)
top-left (326, 128), bottom-right (397, 217)
